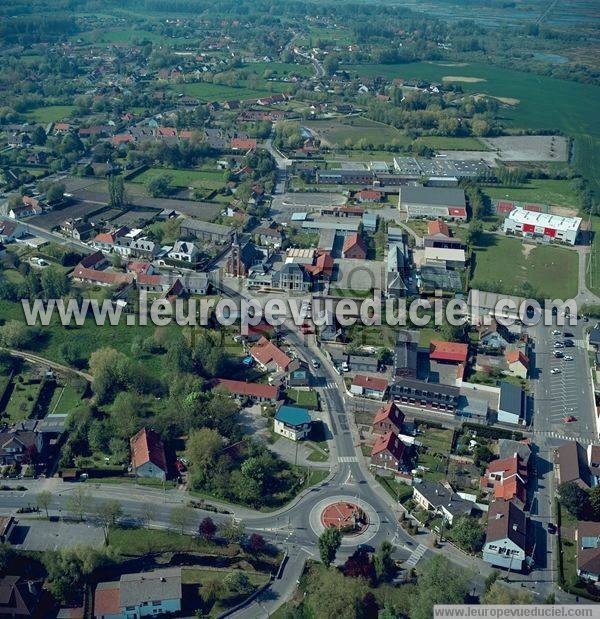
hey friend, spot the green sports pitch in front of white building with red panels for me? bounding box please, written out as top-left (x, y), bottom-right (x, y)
top-left (471, 234), bottom-right (578, 299)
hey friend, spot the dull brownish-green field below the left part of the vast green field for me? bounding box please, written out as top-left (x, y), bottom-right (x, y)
top-left (304, 116), bottom-right (410, 149)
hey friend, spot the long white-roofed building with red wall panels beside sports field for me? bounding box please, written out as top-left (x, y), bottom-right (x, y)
top-left (504, 208), bottom-right (581, 245)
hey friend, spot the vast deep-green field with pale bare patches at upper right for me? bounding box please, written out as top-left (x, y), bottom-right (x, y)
top-left (344, 62), bottom-right (600, 137)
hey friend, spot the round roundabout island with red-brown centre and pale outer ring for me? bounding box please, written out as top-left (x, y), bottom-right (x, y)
top-left (309, 495), bottom-right (381, 546)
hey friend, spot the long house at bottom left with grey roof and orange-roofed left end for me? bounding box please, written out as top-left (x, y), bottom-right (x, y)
top-left (94, 567), bottom-right (182, 619)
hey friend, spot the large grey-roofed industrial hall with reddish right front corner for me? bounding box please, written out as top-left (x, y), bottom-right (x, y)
top-left (398, 187), bottom-right (467, 221)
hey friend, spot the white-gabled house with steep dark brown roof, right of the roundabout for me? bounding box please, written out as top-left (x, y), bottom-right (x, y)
top-left (483, 500), bottom-right (529, 571)
